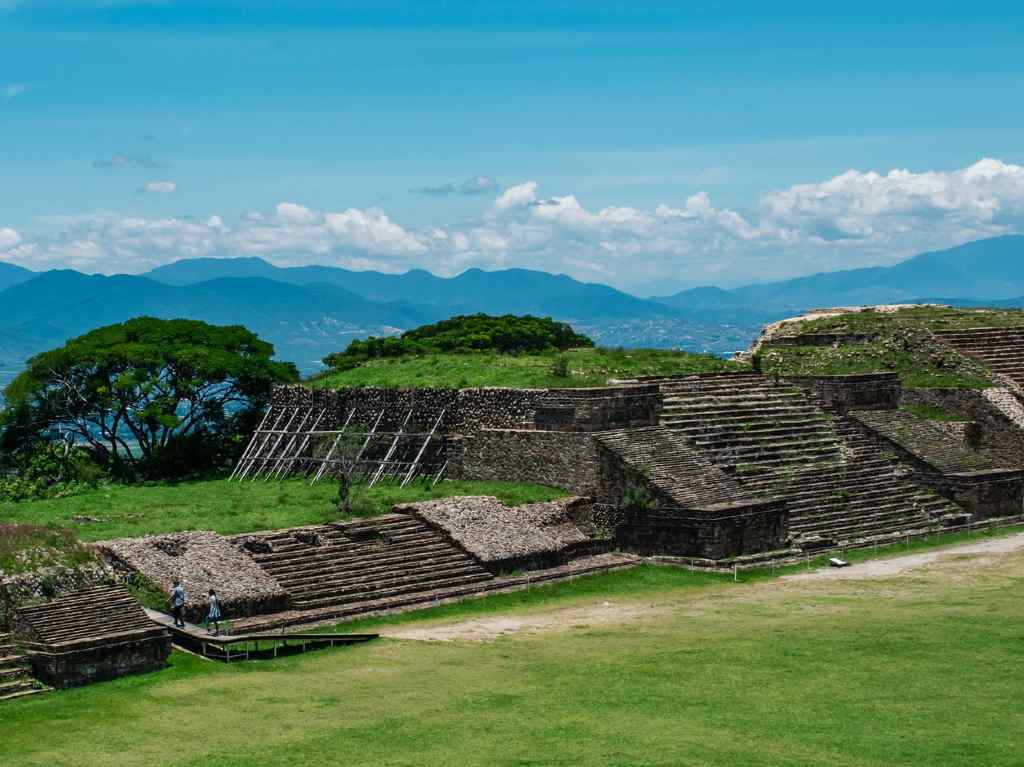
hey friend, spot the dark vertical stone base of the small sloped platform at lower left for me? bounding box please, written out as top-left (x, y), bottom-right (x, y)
top-left (29, 632), bottom-right (171, 689)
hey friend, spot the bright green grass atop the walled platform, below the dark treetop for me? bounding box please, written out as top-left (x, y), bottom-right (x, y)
top-left (310, 348), bottom-right (746, 388)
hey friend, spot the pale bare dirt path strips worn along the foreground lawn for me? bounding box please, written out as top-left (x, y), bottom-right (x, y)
top-left (381, 532), bottom-right (1024, 642)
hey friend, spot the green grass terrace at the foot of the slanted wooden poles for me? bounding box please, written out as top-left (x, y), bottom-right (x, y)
top-left (0, 479), bottom-right (565, 541)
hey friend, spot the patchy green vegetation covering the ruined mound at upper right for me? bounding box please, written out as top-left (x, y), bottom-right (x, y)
top-left (757, 305), bottom-right (1024, 388)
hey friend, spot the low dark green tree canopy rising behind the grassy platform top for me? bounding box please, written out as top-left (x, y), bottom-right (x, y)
top-left (324, 314), bottom-right (594, 369)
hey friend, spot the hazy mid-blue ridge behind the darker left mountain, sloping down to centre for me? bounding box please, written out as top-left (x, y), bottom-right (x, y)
top-left (145, 258), bottom-right (674, 322)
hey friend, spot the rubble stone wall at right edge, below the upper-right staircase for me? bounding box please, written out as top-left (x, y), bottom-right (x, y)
top-left (902, 388), bottom-right (1024, 467)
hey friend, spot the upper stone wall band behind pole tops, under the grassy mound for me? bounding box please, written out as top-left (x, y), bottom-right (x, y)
top-left (267, 384), bottom-right (662, 434)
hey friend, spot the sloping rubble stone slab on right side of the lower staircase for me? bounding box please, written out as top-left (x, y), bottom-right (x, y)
top-left (394, 496), bottom-right (590, 572)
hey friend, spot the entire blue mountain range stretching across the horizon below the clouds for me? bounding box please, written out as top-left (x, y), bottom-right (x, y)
top-left (0, 230), bottom-right (1024, 385)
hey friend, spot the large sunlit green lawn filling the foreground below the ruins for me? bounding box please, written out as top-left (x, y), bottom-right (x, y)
top-left (0, 536), bottom-right (1024, 767)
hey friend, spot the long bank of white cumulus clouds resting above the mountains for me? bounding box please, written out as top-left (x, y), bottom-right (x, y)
top-left (6, 159), bottom-right (1024, 287)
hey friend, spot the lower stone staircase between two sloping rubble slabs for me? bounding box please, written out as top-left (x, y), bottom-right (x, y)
top-left (241, 514), bottom-right (494, 616)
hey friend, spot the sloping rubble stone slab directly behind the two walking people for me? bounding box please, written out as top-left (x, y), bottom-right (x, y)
top-left (96, 531), bottom-right (289, 622)
